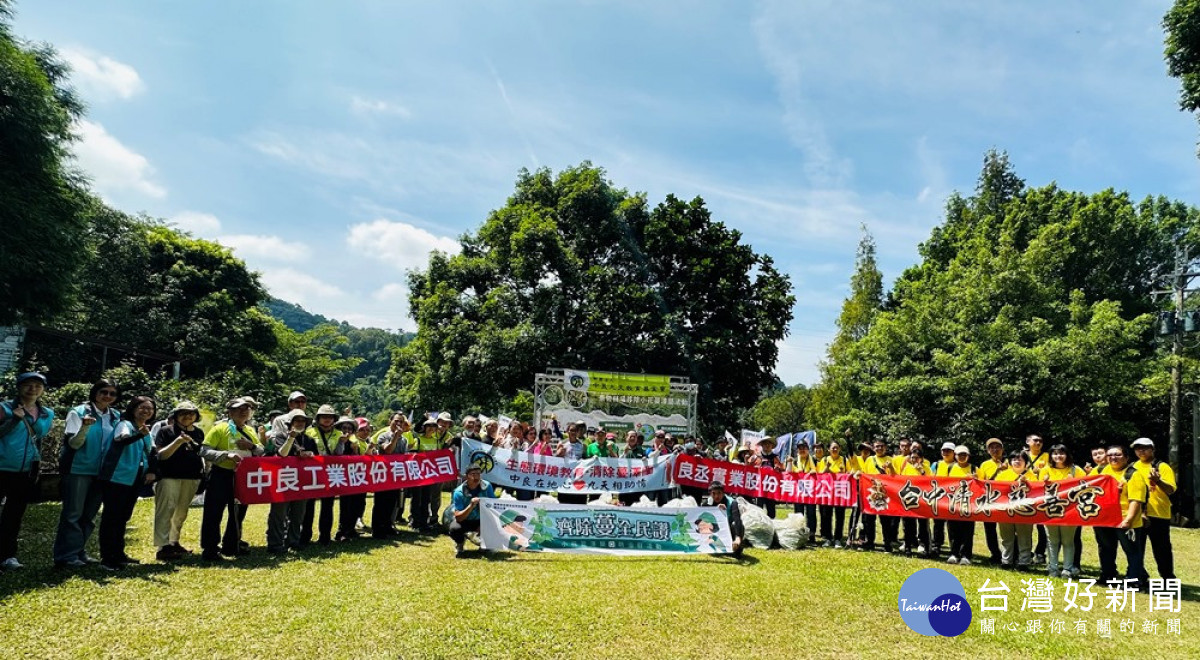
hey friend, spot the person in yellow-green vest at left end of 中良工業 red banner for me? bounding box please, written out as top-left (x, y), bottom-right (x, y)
top-left (200, 397), bottom-right (264, 560)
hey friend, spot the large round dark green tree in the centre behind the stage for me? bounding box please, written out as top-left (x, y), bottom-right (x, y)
top-left (389, 163), bottom-right (794, 431)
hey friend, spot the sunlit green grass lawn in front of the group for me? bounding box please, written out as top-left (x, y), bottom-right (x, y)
top-left (0, 500), bottom-right (1200, 660)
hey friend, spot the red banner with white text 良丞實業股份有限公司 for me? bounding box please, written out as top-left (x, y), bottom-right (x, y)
top-left (673, 454), bottom-right (856, 506)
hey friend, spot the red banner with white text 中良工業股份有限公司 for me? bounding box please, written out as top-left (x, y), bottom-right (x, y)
top-left (234, 449), bottom-right (458, 504)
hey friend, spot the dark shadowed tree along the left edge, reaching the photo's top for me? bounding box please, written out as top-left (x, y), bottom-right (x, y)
top-left (0, 0), bottom-right (85, 325)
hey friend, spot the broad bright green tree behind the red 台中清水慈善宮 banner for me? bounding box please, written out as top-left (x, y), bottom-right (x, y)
top-left (820, 155), bottom-right (1198, 456)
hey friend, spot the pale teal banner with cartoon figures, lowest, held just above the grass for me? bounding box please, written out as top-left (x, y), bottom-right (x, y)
top-left (479, 499), bottom-right (733, 554)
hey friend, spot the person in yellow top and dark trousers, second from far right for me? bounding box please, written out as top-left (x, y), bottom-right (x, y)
top-left (1096, 445), bottom-right (1150, 590)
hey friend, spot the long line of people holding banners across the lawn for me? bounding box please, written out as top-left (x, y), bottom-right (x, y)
top-left (0, 372), bottom-right (1176, 587)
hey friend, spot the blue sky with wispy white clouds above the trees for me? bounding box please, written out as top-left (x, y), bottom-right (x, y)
top-left (16, 0), bottom-right (1200, 384)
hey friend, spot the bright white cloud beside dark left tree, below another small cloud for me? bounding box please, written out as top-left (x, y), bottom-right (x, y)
top-left (74, 119), bottom-right (167, 199)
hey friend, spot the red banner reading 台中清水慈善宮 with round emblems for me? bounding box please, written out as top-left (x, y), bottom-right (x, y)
top-left (859, 474), bottom-right (1124, 527)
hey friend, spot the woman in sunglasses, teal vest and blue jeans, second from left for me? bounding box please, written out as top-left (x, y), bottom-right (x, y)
top-left (53, 378), bottom-right (121, 569)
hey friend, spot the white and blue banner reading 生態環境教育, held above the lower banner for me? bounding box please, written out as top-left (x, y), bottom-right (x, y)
top-left (458, 438), bottom-right (671, 494)
